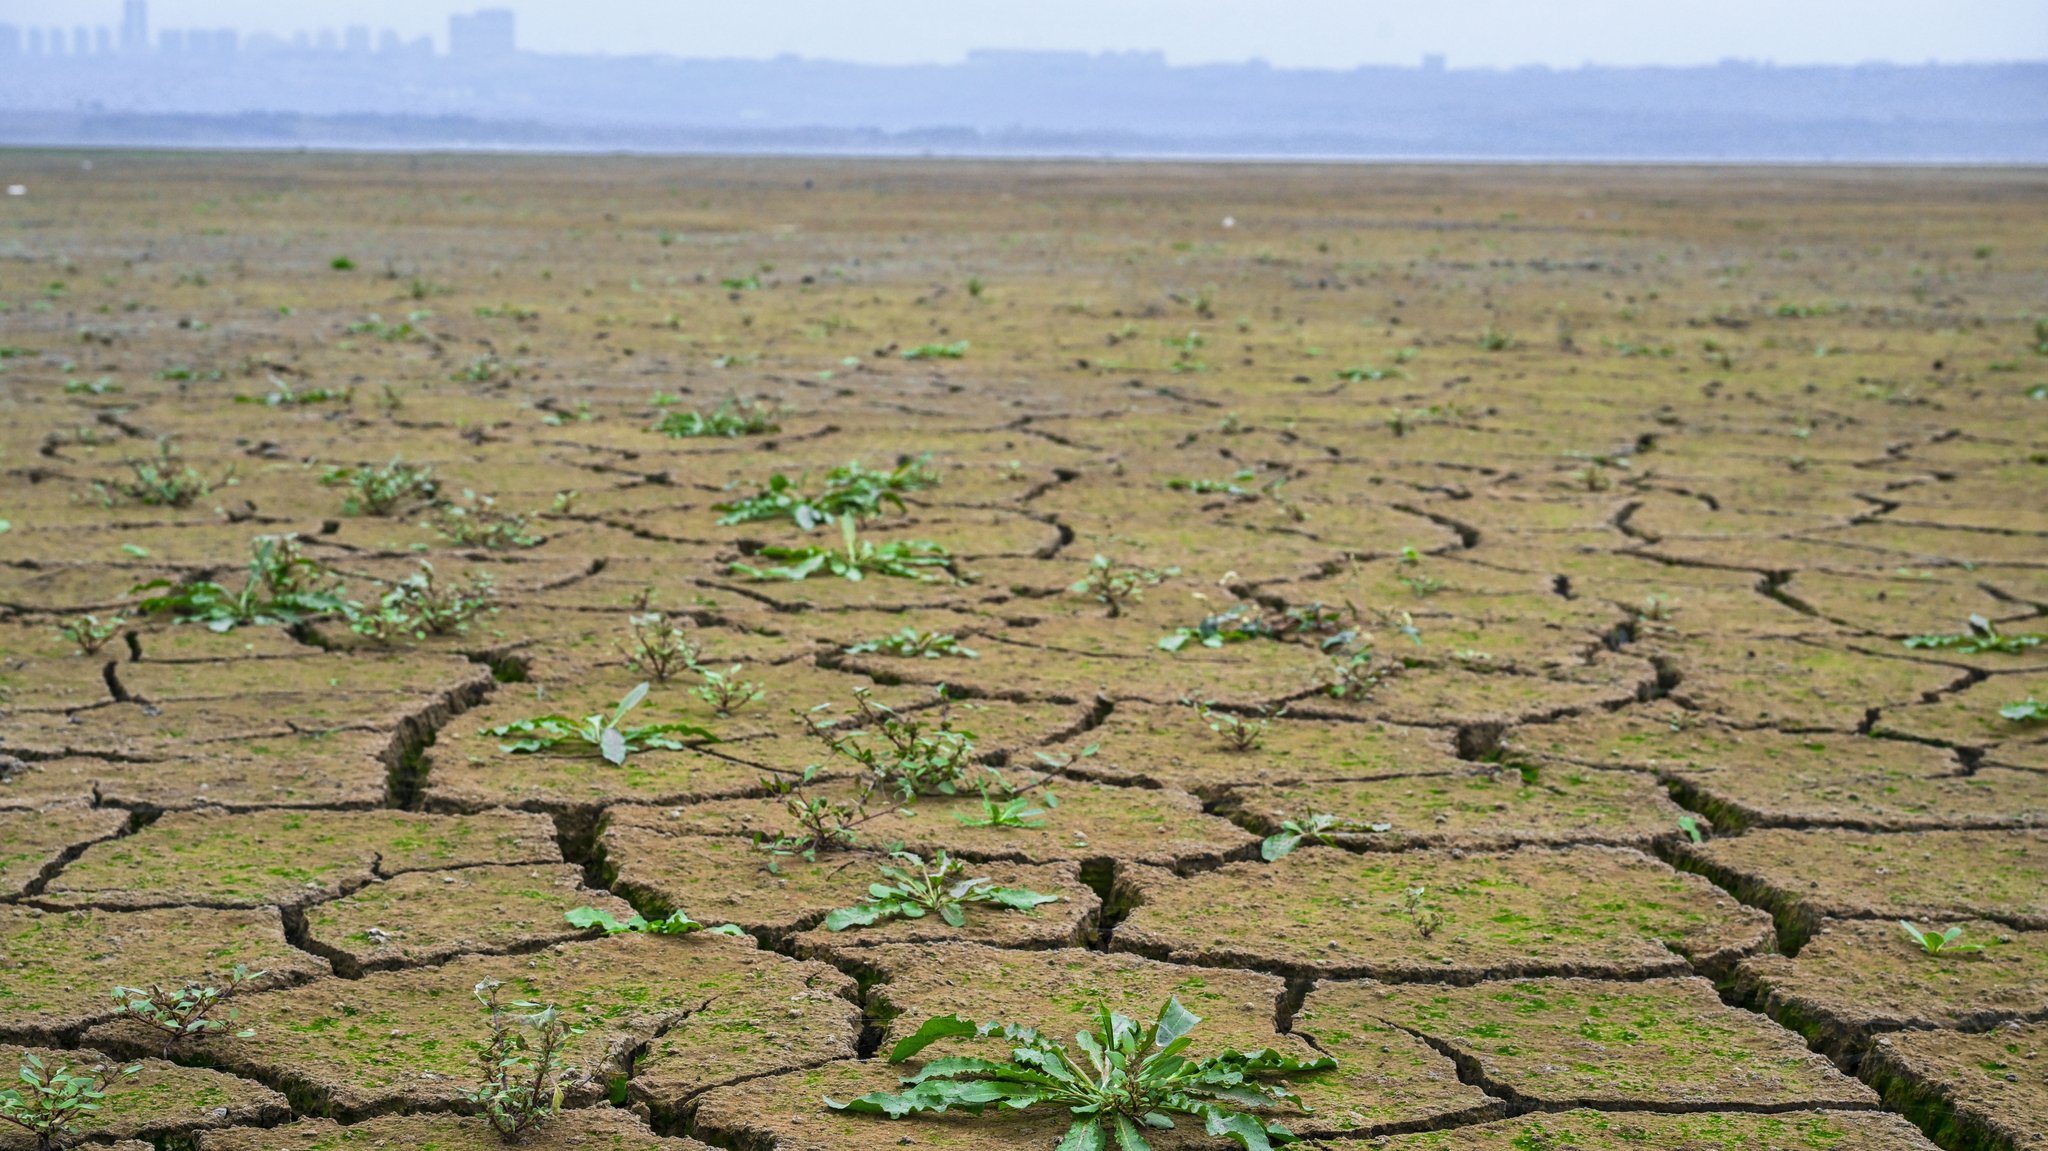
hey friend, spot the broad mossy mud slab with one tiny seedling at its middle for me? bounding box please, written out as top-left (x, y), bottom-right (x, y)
top-left (1112, 848), bottom-right (1772, 983)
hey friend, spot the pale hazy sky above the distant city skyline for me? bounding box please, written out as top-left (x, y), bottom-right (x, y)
top-left (0, 0), bottom-right (2048, 68)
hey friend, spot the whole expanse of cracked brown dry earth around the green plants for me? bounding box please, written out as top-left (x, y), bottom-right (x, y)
top-left (0, 154), bottom-right (2048, 1151)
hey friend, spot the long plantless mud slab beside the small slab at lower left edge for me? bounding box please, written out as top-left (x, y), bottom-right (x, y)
top-left (37, 811), bottom-right (561, 909)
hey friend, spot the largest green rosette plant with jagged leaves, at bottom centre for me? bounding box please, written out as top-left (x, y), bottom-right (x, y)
top-left (825, 997), bottom-right (1337, 1151)
